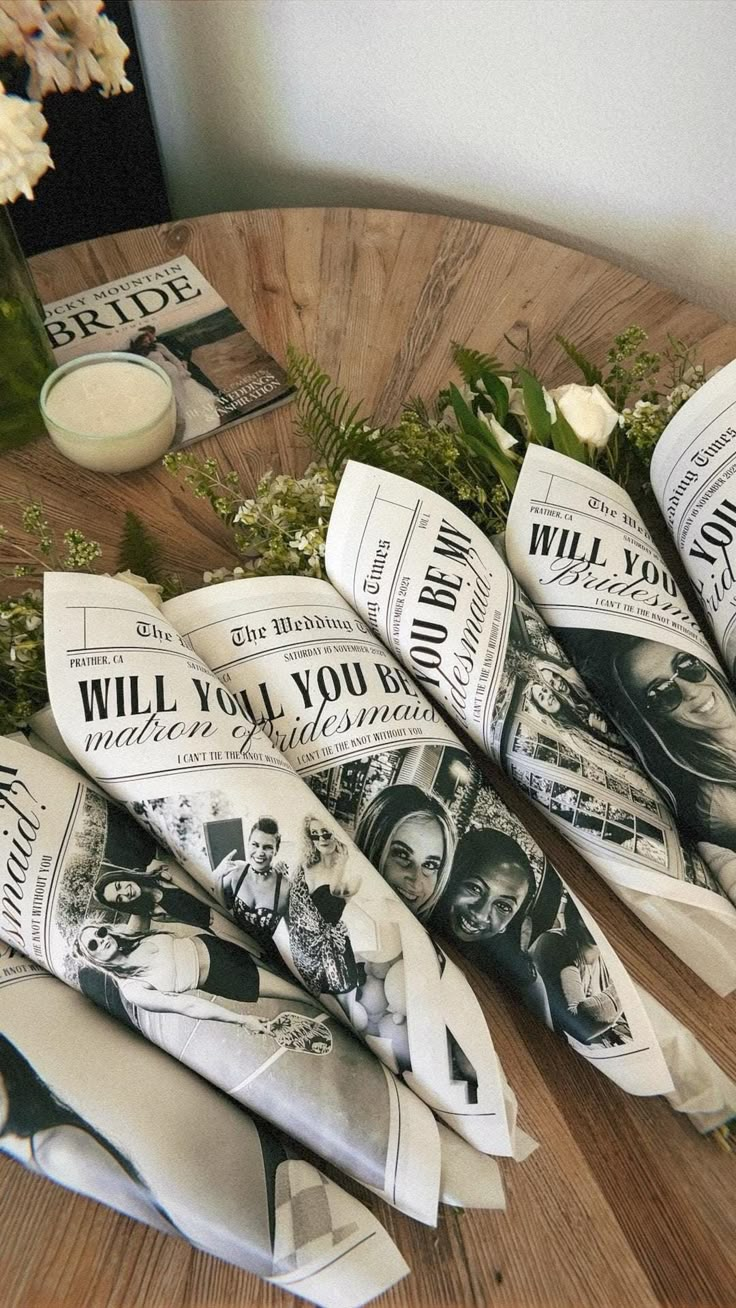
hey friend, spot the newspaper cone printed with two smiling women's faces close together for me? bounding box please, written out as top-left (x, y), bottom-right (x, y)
top-left (162, 578), bottom-right (671, 1109)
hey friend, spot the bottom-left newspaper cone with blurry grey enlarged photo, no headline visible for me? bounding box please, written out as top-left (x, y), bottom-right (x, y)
top-left (0, 941), bottom-right (408, 1308)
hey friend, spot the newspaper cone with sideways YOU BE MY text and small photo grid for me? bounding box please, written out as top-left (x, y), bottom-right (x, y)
top-left (327, 463), bottom-right (736, 994)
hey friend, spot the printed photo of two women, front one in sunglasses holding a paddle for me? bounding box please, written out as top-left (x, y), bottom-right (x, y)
top-left (73, 808), bottom-right (332, 1054)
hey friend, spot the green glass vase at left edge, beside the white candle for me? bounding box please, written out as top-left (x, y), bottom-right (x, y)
top-left (0, 204), bottom-right (55, 453)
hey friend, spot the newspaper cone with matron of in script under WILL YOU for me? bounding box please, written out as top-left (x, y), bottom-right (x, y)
top-left (44, 574), bottom-right (515, 1154)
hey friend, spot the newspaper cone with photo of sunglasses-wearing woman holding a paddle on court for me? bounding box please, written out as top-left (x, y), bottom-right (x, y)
top-left (0, 738), bottom-right (502, 1223)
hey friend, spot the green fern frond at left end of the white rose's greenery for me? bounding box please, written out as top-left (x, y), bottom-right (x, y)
top-left (288, 347), bottom-right (395, 476)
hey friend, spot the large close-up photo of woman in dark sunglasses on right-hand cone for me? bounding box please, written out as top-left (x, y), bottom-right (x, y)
top-left (613, 640), bottom-right (736, 897)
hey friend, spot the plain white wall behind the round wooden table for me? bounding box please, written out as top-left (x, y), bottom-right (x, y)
top-left (135, 0), bottom-right (736, 318)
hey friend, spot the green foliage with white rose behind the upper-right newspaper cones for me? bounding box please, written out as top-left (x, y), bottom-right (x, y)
top-left (289, 326), bottom-right (706, 532)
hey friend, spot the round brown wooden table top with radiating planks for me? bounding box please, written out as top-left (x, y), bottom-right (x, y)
top-left (0, 209), bottom-right (736, 1308)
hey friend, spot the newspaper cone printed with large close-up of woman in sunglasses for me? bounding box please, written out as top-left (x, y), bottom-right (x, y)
top-left (506, 446), bottom-right (736, 941)
